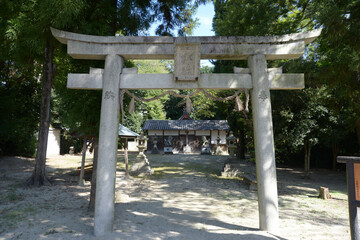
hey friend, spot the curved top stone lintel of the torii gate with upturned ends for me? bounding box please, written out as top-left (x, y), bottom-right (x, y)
top-left (51, 28), bottom-right (321, 60)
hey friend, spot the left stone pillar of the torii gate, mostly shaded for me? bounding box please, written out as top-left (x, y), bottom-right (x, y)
top-left (94, 55), bottom-right (123, 236)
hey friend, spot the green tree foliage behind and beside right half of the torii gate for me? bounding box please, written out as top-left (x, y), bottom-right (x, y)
top-left (213, 0), bottom-right (360, 167)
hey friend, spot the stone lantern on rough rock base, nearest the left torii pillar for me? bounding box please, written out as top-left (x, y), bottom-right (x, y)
top-left (130, 131), bottom-right (154, 177)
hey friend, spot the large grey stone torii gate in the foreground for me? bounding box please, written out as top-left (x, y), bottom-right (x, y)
top-left (51, 29), bottom-right (321, 236)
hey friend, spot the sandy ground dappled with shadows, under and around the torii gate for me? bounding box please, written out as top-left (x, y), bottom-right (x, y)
top-left (0, 155), bottom-right (350, 240)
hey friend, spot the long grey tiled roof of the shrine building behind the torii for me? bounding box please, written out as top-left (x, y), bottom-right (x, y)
top-left (143, 120), bottom-right (230, 130)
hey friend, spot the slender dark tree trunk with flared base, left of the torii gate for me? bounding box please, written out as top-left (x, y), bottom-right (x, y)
top-left (27, 41), bottom-right (56, 187)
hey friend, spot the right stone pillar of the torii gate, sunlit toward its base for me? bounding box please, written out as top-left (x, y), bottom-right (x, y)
top-left (248, 54), bottom-right (279, 233)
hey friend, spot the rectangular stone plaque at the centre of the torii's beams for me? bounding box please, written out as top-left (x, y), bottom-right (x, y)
top-left (174, 43), bottom-right (200, 81)
